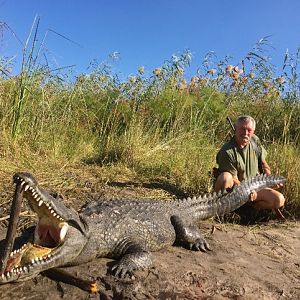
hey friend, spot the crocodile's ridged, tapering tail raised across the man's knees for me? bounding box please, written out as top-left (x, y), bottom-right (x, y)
top-left (185, 174), bottom-right (285, 220)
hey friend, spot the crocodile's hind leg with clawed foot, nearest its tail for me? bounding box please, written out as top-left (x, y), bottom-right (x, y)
top-left (171, 216), bottom-right (211, 252)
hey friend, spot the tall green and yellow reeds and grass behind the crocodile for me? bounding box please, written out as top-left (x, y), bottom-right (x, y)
top-left (0, 19), bottom-right (300, 216)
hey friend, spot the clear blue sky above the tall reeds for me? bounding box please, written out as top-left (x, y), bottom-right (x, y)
top-left (0, 0), bottom-right (300, 77)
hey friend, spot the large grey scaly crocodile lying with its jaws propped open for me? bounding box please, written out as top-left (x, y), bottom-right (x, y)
top-left (0, 173), bottom-right (285, 284)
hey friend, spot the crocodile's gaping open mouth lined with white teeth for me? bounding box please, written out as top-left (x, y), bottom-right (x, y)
top-left (0, 177), bottom-right (69, 278)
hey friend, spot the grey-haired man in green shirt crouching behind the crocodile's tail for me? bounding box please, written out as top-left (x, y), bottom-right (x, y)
top-left (215, 116), bottom-right (285, 211)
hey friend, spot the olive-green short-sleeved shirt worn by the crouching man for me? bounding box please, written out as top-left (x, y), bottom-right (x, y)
top-left (217, 135), bottom-right (267, 181)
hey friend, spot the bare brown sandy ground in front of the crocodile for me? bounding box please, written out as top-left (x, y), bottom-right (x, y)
top-left (0, 175), bottom-right (300, 300)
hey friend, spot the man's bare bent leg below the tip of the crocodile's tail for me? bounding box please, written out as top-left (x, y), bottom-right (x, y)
top-left (252, 188), bottom-right (285, 209)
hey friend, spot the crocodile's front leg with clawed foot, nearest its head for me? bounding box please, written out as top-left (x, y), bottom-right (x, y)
top-left (112, 239), bottom-right (152, 278)
